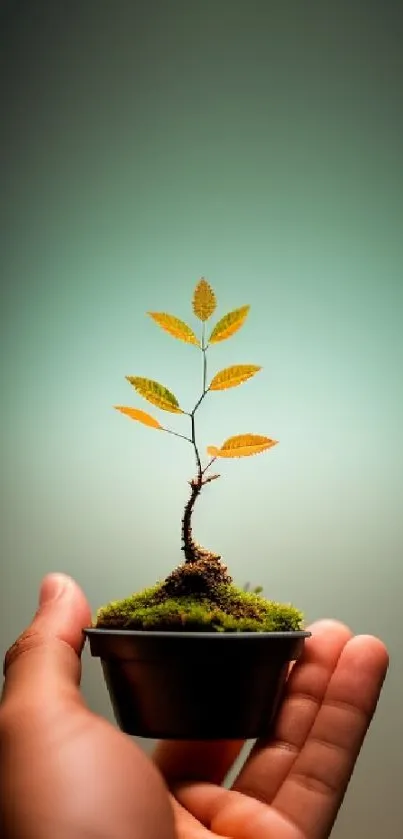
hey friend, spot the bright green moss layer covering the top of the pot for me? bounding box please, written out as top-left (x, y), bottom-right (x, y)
top-left (96, 583), bottom-right (303, 632)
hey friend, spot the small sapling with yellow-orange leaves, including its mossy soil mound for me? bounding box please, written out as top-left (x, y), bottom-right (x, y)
top-left (96, 278), bottom-right (302, 632)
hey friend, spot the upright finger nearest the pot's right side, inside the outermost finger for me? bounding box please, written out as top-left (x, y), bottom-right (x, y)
top-left (233, 620), bottom-right (351, 803)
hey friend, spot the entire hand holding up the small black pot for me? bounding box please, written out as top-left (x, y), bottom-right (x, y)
top-left (0, 574), bottom-right (388, 839)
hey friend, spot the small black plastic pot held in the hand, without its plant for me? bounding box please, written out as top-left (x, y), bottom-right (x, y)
top-left (84, 628), bottom-right (310, 740)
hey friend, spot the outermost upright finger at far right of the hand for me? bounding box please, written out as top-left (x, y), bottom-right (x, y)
top-left (272, 636), bottom-right (388, 839)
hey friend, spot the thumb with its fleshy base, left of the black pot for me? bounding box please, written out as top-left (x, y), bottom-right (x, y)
top-left (0, 575), bottom-right (175, 839)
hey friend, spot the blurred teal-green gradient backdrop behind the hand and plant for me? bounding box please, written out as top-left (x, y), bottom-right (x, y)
top-left (0, 0), bottom-right (403, 839)
